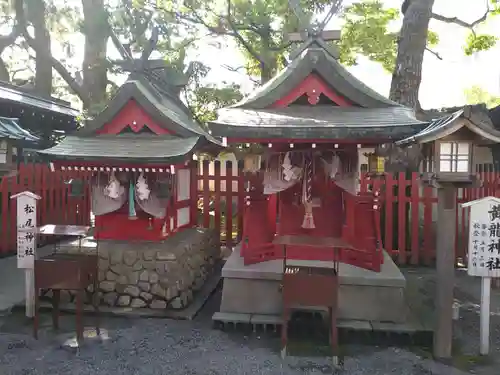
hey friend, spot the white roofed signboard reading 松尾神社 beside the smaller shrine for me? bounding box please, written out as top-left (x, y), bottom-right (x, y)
top-left (11, 192), bottom-right (40, 269)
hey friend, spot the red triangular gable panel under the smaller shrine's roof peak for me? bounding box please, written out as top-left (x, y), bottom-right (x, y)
top-left (96, 99), bottom-right (173, 135)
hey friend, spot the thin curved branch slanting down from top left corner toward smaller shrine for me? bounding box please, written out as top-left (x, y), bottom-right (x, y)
top-left (14, 0), bottom-right (88, 102)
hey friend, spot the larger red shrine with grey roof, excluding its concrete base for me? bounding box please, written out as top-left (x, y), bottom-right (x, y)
top-left (210, 35), bottom-right (426, 271)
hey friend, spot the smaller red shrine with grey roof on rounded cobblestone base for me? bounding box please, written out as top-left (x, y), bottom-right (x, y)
top-left (40, 65), bottom-right (225, 309)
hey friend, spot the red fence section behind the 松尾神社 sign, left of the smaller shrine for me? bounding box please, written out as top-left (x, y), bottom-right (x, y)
top-left (0, 163), bottom-right (90, 256)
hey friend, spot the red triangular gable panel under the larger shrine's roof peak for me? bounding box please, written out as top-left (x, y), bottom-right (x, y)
top-left (272, 73), bottom-right (353, 108)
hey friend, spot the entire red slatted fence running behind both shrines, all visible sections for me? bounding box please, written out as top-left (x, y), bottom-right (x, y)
top-left (0, 161), bottom-right (500, 265)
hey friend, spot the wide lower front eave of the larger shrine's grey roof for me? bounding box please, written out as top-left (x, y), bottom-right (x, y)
top-left (210, 105), bottom-right (427, 140)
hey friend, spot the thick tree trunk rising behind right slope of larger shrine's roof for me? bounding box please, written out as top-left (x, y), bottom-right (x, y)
top-left (389, 0), bottom-right (434, 110)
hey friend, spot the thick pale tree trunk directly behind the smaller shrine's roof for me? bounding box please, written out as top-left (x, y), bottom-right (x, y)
top-left (82, 0), bottom-right (109, 113)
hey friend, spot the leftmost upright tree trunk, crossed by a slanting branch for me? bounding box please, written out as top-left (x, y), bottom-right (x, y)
top-left (26, 0), bottom-right (52, 98)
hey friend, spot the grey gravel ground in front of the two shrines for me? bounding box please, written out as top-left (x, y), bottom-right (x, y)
top-left (0, 271), bottom-right (500, 375)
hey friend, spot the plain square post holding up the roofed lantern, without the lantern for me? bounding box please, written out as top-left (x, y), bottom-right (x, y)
top-left (434, 184), bottom-right (457, 359)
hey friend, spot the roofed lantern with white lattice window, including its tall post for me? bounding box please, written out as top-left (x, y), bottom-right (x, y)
top-left (396, 105), bottom-right (500, 359)
